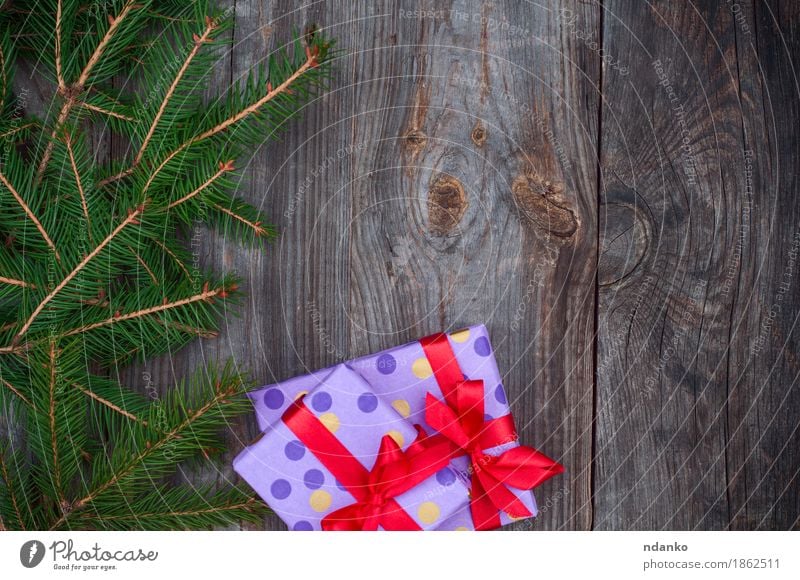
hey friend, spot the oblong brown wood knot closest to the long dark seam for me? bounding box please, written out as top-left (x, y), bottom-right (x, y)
top-left (511, 175), bottom-right (578, 239)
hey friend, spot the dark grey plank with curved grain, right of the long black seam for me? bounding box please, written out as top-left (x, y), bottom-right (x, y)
top-left (594, 1), bottom-right (800, 529)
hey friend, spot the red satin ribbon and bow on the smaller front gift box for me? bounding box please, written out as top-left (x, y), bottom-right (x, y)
top-left (282, 399), bottom-right (452, 531)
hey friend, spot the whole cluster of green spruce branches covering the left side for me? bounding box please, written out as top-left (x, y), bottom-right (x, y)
top-left (0, 0), bottom-right (333, 529)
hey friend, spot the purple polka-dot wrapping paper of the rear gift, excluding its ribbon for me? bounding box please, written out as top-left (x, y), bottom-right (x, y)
top-left (248, 324), bottom-right (537, 530)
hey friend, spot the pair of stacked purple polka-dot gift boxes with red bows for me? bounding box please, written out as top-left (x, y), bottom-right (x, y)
top-left (234, 325), bottom-right (563, 530)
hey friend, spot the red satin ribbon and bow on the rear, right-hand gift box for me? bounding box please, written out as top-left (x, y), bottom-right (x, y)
top-left (420, 333), bottom-right (564, 530)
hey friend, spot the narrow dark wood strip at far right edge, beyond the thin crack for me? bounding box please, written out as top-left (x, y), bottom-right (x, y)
top-left (726, 2), bottom-right (800, 530)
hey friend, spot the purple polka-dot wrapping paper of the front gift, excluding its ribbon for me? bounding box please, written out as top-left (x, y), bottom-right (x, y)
top-left (233, 365), bottom-right (468, 530)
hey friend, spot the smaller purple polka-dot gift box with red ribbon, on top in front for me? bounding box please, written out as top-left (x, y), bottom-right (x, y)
top-left (234, 365), bottom-right (468, 530)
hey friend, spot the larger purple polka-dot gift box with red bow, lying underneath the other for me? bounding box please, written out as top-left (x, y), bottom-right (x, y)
top-left (249, 325), bottom-right (563, 530)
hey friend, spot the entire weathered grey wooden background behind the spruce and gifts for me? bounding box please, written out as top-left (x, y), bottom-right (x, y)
top-left (112, 0), bottom-right (800, 530)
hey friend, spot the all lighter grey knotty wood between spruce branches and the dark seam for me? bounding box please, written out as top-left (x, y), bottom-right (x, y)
top-left (173, 0), bottom-right (599, 528)
